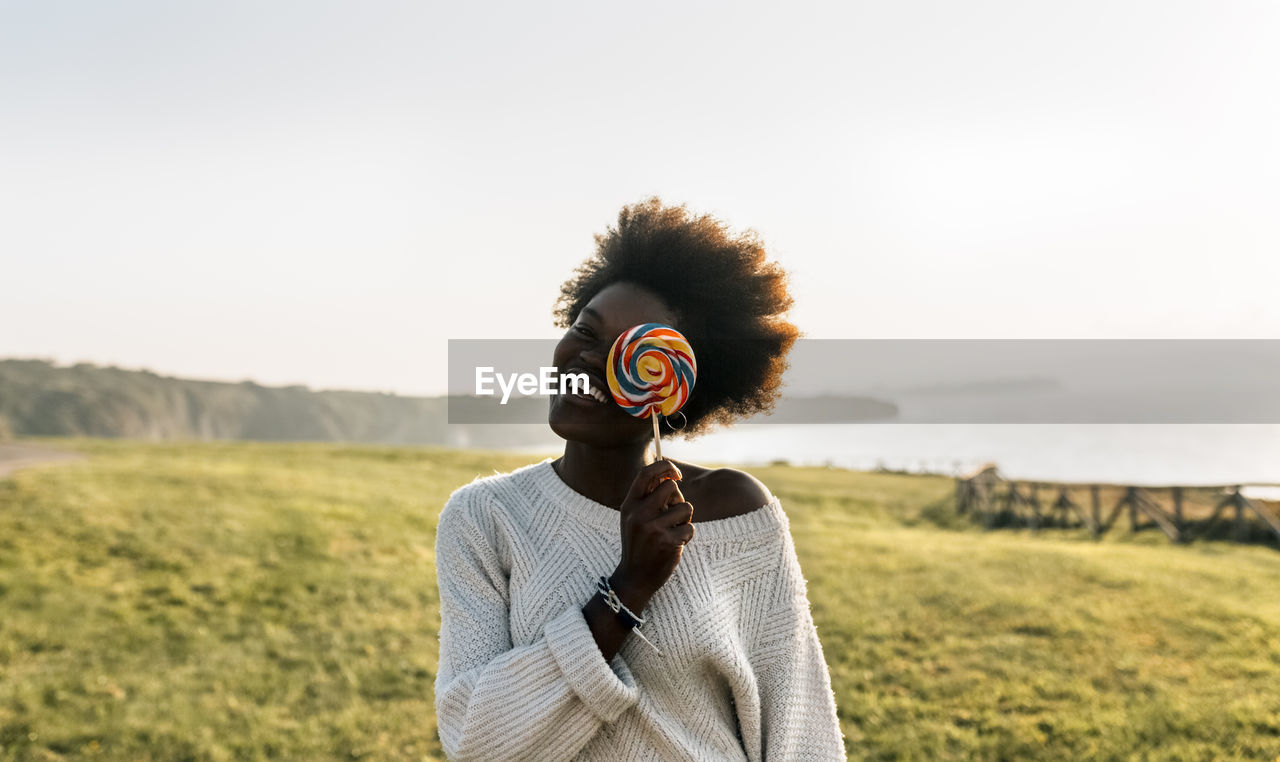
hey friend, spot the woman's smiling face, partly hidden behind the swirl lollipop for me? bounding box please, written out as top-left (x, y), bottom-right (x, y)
top-left (548, 283), bottom-right (676, 447)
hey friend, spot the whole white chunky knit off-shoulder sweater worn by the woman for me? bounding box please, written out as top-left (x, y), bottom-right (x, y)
top-left (435, 460), bottom-right (845, 761)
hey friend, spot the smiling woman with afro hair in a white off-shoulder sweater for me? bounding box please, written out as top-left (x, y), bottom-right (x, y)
top-left (435, 199), bottom-right (845, 759)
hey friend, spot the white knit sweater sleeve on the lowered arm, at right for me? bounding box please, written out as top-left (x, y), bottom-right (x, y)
top-left (751, 528), bottom-right (845, 761)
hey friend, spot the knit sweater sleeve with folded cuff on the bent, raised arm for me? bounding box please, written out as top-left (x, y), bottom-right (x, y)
top-left (435, 488), bottom-right (639, 759)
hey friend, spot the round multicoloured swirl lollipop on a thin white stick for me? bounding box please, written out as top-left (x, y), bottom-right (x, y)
top-left (604, 323), bottom-right (698, 458)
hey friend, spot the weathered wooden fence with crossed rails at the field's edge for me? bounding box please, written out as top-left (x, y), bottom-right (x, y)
top-left (956, 466), bottom-right (1280, 543)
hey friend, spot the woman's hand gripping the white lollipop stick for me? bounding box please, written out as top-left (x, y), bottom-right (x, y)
top-left (611, 460), bottom-right (694, 613)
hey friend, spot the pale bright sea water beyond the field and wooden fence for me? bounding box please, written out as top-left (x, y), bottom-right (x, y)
top-left (504, 424), bottom-right (1280, 499)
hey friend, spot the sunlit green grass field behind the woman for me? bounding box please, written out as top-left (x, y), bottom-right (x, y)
top-left (0, 439), bottom-right (1280, 762)
